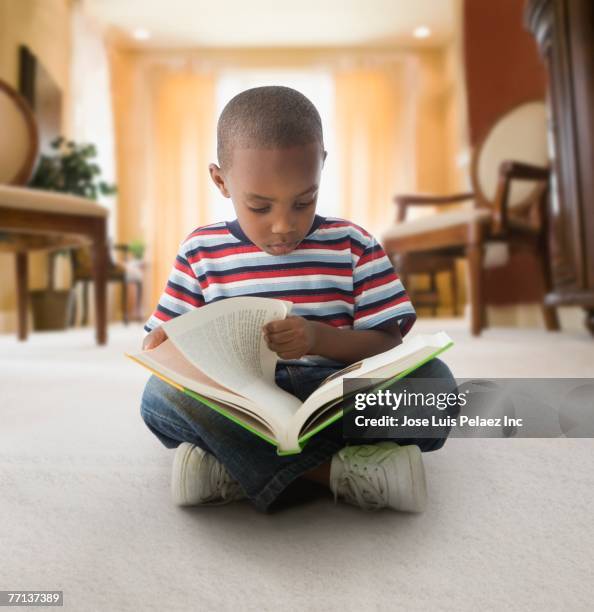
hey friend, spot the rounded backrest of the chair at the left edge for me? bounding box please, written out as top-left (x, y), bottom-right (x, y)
top-left (0, 81), bottom-right (39, 185)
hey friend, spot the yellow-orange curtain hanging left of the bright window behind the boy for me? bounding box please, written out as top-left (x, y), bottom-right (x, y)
top-left (146, 68), bottom-right (216, 307)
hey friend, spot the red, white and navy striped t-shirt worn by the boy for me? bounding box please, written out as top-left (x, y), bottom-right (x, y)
top-left (144, 215), bottom-right (416, 365)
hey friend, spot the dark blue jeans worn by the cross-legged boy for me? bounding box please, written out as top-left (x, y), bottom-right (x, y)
top-left (141, 359), bottom-right (459, 512)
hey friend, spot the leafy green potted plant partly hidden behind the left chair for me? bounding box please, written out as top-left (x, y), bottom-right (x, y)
top-left (29, 137), bottom-right (116, 330)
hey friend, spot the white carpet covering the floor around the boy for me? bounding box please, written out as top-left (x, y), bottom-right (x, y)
top-left (0, 320), bottom-right (594, 611)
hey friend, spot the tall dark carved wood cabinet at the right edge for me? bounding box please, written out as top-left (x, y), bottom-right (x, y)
top-left (525, 0), bottom-right (594, 334)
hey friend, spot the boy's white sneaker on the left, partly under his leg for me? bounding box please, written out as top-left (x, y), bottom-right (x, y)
top-left (171, 442), bottom-right (246, 506)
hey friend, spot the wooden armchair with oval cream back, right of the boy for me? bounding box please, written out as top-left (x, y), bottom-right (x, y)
top-left (381, 101), bottom-right (559, 335)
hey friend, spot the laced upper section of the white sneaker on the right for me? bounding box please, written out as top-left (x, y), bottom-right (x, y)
top-left (334, 455), bottom-right (388, 510)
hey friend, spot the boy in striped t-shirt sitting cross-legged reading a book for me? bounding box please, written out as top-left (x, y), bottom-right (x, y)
top-left (141, 87), bottom-right (453, 512)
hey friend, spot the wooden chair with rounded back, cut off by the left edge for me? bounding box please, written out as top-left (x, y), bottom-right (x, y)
top-left (0, 81), bottom-right (108, 344)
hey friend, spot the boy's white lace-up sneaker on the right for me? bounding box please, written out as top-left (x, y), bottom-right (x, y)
top-left (330, 442), bottom-right (427, 512)
